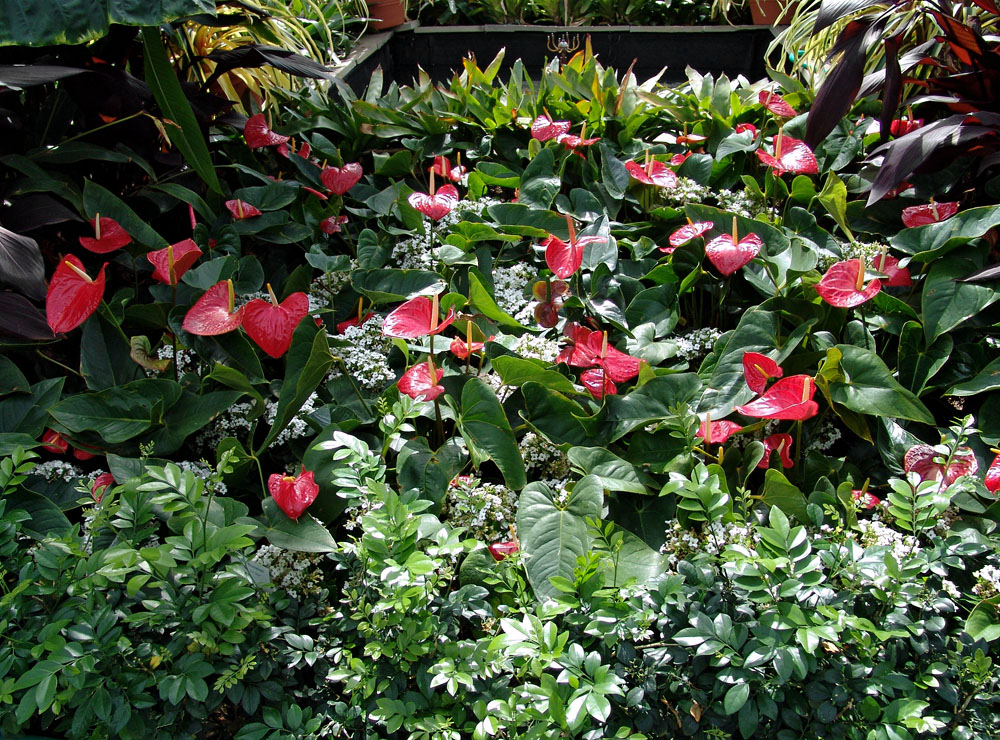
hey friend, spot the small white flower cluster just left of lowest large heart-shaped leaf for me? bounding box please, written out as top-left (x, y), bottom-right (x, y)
top-left (442, 475), bottom-right (517, 542)
